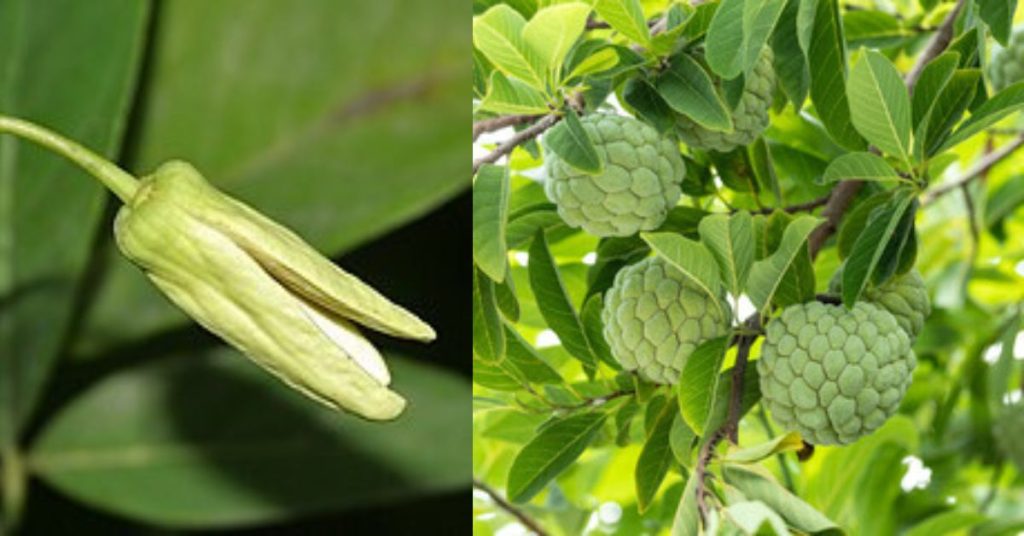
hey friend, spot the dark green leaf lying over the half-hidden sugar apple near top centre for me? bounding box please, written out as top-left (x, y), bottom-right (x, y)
top-left (654, 53), bottom-right (733, 131)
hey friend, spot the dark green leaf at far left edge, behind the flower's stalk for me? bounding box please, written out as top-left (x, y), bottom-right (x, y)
top-left (0, 0), bottom-right (148, 447)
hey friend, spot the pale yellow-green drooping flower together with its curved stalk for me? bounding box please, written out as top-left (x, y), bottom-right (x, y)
top-left (0, 116), bottom-right (434, 420)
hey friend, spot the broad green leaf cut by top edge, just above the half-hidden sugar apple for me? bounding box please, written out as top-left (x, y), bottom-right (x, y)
top-left (705, 0), bottom-right (785, 79)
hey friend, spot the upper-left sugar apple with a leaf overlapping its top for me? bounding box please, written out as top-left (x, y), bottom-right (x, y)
top-left (542, 114), bottom-right (686, 237)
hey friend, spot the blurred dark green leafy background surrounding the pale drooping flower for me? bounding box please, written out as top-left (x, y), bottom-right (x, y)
top-left (0, 0), bottom-right (471, 534)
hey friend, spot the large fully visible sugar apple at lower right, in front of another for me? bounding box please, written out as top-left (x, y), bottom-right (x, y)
top-left (757, 301), bottom-right (916, 445)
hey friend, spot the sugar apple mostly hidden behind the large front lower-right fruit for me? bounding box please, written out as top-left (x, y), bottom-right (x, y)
top-left (828, 270), bottom-right (932, 344)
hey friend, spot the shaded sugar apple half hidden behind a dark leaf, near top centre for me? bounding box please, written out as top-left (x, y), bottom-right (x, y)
top-left (676, 46), bottom-right (775, 153)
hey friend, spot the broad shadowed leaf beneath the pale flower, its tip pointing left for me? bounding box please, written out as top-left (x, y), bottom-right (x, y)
top-left (30, 349), bottom-right (471, 528)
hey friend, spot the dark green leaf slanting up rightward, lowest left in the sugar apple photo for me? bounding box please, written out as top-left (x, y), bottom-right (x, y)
top-left (507, 412), bottom-right (607, 502)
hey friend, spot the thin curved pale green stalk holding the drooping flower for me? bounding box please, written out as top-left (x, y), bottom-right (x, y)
top-left (0, 115), bottom-right (138, 203)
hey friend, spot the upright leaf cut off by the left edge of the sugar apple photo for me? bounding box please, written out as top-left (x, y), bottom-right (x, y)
top-left (473, 164), bottom-right (509, 283)
